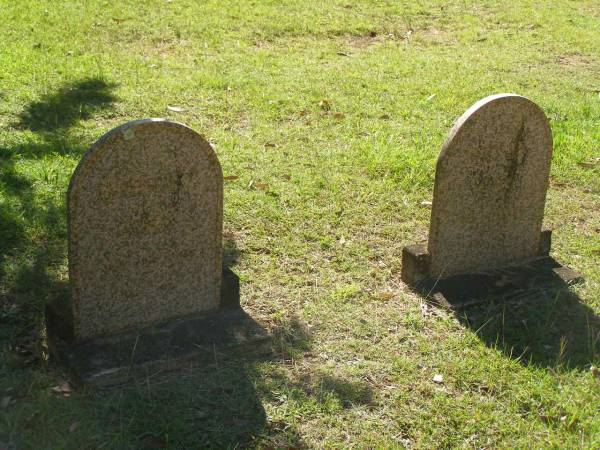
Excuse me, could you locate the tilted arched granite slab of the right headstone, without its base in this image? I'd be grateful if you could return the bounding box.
[428,94,552,277]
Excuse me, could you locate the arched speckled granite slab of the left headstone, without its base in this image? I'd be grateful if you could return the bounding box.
[68,119,223,340]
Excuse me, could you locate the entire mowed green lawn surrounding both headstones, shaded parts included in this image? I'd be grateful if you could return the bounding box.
[0,0,600,449]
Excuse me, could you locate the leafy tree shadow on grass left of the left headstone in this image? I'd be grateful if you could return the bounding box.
[0,78,115,347]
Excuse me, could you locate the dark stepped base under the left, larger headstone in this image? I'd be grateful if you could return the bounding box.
[48,273,271,388]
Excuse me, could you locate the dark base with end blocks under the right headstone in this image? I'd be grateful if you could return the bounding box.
[402,230,583,310]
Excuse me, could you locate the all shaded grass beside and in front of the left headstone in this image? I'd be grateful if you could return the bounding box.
[0,79,322,448]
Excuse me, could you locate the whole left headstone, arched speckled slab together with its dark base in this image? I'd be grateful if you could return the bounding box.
[47,119,269,386]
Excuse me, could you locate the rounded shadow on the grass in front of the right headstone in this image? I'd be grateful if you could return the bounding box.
[455,282,600,370]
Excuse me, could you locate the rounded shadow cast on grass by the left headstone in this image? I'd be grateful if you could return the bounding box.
[93,342,267,448]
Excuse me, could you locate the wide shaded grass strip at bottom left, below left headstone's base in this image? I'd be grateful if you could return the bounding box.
[0,319,314,449]
